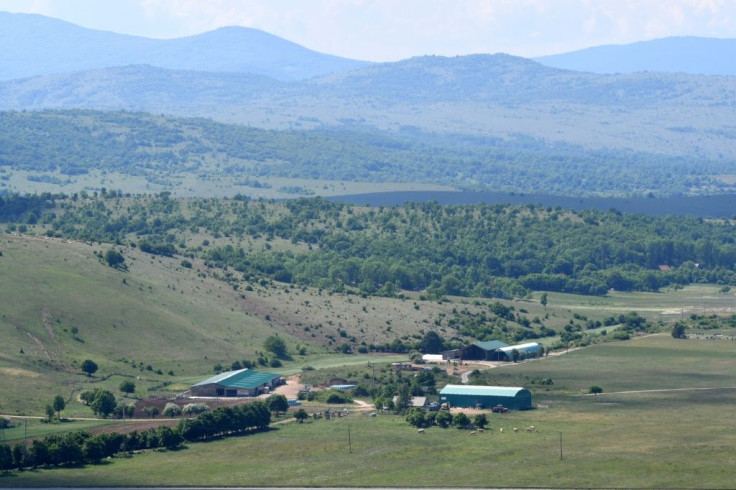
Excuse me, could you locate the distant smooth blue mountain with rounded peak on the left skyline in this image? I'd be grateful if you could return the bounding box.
[0,12,369,81]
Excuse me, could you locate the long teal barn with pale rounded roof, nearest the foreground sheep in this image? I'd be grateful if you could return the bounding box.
[440,385,532,410]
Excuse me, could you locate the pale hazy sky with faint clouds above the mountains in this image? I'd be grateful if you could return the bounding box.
[0,0,736,61]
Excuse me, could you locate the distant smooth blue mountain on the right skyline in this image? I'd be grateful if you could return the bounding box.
[535,37,736,76]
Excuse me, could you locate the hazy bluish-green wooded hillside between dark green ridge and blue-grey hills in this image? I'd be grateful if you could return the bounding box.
[0,111,736,196]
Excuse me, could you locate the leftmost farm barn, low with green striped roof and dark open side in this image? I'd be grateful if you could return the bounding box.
[190,369,284,397]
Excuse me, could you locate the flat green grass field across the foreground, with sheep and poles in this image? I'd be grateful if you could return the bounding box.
[0,335,736,488]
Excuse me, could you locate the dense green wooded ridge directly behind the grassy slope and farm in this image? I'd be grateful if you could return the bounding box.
[0,191,736,298]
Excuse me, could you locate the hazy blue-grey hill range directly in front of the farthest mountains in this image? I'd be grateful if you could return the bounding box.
[0,55,736,165]
